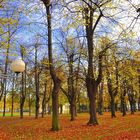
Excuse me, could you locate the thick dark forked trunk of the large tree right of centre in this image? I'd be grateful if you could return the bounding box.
[84,5,103,125]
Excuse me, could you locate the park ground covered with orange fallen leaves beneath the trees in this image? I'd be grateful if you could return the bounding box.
[0,112,140,140]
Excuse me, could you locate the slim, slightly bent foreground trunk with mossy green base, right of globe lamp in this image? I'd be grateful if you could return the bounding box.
[42,0,61,131]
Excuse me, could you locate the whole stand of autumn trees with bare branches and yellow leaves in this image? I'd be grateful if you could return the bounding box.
[0,0,140,131]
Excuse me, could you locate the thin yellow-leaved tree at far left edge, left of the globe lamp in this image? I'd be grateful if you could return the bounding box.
[0,1,19,116]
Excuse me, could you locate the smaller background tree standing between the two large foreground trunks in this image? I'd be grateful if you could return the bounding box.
[60,34,83,121]
